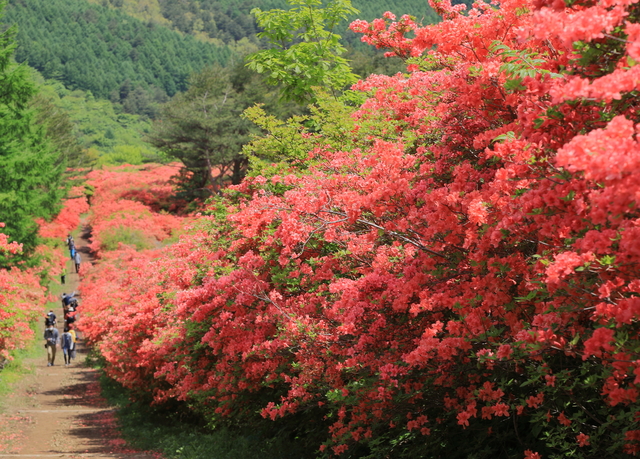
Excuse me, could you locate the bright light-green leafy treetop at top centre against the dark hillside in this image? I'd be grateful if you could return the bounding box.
[247,0,358,103]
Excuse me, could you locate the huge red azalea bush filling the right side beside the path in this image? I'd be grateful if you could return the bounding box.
[82,0,640,457]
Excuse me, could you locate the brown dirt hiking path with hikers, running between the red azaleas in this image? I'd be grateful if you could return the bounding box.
[0,226,159,459]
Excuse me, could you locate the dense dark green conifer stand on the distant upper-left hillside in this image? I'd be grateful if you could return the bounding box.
[4,0,230,98]
